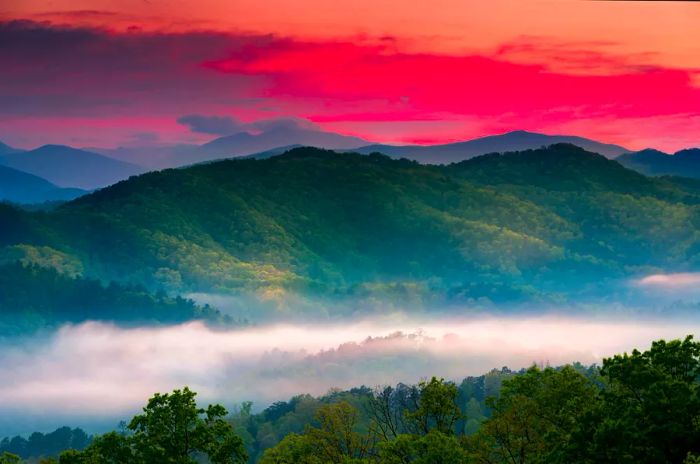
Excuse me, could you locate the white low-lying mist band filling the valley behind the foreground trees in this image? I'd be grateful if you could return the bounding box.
[0,314,700,435]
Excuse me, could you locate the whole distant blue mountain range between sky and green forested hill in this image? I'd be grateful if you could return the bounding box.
[0,129,700,202]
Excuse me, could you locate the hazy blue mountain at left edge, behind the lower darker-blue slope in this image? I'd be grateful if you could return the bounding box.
[0,145,143,190]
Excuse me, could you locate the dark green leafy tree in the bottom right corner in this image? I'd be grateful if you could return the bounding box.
[570,336,700,464]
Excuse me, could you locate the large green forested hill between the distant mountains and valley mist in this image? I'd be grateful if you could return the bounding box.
[0,145,700,302]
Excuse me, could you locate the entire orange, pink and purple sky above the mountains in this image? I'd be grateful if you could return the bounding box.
[0,0,700,152]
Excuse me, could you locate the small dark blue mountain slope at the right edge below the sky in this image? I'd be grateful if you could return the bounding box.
[617,148,700,178]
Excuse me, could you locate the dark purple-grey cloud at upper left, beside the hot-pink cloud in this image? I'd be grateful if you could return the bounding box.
[0,20,275,117]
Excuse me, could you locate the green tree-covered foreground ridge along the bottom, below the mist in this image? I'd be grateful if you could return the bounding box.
[13,336,700,464]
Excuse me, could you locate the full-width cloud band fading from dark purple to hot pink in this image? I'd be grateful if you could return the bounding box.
[0,21,700,150]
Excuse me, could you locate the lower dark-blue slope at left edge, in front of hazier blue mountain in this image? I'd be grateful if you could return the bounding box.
[0,166,85,203]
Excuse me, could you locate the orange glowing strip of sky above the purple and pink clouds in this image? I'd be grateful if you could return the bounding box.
[6,0,700,68]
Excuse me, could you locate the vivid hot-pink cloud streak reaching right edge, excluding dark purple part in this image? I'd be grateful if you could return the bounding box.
[205,41,700,120]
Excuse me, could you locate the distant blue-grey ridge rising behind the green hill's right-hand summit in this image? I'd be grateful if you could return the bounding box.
[353,131,629,164]
